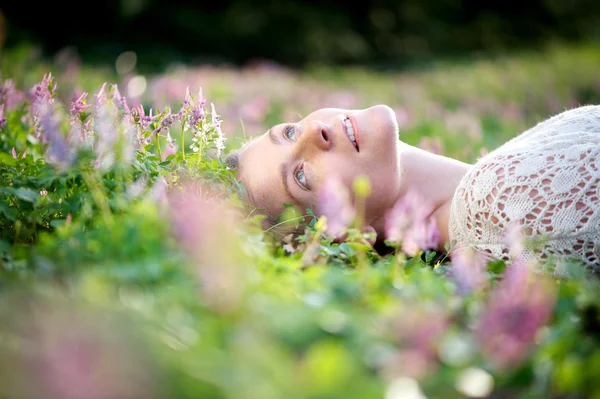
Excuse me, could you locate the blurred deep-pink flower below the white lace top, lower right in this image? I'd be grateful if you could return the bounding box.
[475,258,555,368]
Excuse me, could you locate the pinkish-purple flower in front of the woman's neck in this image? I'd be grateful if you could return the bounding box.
[385,190,440,256]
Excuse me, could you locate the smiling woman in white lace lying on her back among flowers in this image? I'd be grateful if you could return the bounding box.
[227,105,600,269]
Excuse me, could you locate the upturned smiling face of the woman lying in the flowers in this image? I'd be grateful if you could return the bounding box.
[238,105,400,224]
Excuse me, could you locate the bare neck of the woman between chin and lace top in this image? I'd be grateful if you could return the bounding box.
[373,143,471,250]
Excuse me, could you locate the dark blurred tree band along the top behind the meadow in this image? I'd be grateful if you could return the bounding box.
[0,0,600,68]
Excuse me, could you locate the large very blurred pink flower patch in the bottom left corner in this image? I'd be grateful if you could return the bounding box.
[0,290,164,399]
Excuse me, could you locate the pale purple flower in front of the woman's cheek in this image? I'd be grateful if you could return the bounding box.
[318,175,356,236]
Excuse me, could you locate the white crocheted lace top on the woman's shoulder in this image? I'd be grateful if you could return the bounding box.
[449,105,600,273]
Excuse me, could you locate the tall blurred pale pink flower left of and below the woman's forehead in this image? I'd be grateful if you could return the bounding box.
[168,183,244,312]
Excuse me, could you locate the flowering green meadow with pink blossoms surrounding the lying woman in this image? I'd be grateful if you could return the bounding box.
[0,43,600,399]
